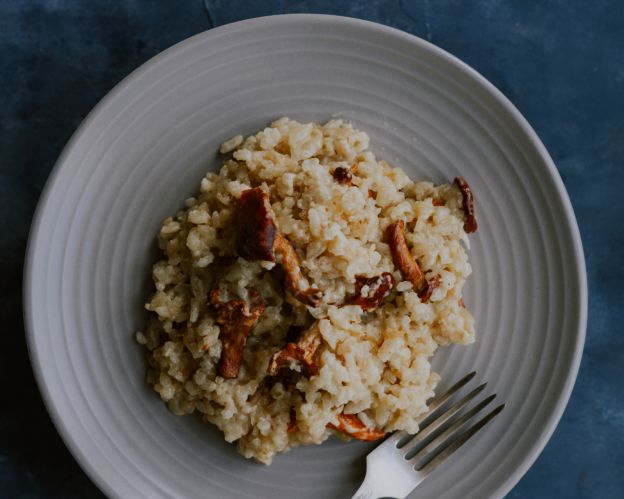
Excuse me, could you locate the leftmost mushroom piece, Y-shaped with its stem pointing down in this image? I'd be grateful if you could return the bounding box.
[210,289,265,379]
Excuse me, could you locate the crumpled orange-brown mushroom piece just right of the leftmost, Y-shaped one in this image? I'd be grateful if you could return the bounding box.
[267,322,322,377]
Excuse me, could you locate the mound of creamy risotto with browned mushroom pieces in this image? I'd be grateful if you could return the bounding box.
[137,118,477,464]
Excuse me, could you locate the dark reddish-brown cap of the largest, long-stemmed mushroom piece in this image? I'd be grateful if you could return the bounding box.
[238,187,277,262]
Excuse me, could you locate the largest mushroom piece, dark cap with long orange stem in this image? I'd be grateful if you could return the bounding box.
[238,187,323,307]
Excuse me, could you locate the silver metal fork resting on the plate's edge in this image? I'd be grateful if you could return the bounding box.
[352,372,505,499]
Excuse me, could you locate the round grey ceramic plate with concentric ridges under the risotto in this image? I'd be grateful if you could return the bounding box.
[25,15,587,498]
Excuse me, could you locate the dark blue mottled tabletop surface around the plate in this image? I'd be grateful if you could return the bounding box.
[0,0,624,498]
